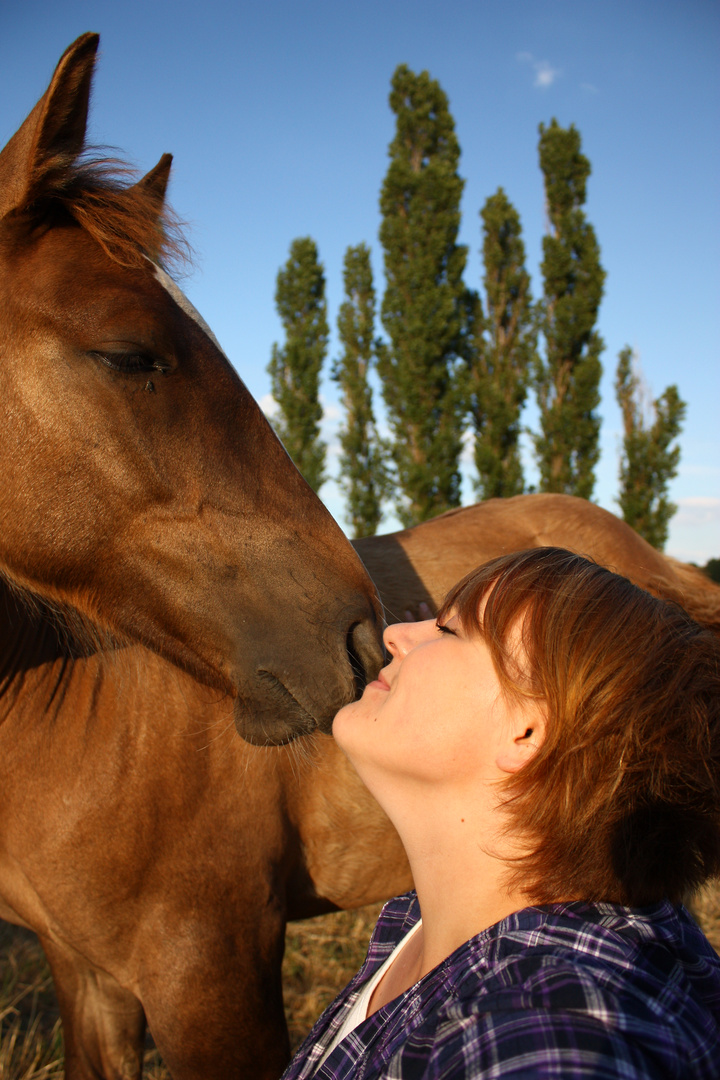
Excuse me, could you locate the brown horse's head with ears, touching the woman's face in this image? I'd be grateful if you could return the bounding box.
[0,33,381,743]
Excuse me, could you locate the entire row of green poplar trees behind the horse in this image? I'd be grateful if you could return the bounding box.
[268,65,685,549]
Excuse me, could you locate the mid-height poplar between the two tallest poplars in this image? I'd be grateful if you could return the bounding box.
[470,188,536,499]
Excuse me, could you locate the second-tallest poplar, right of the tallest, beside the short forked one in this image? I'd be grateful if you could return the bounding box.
[534,120,604,499]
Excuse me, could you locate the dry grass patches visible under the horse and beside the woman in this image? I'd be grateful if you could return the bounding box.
[0,882,720,1080]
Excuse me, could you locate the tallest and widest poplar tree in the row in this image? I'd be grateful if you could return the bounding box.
[378,65,475,525]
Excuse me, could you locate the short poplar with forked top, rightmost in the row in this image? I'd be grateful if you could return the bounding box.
[615,348,685,551]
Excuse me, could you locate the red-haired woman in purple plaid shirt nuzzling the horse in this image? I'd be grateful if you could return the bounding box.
[285,548,720,1080]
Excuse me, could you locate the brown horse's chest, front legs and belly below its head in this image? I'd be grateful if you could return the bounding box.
[0,574,409,1080]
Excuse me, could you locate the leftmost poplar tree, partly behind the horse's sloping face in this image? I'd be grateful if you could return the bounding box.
[268,237,328,491]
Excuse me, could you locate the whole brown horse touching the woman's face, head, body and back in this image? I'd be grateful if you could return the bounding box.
[0,29,720,1080]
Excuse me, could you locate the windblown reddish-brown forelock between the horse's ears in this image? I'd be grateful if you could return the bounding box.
[32,157,192,270]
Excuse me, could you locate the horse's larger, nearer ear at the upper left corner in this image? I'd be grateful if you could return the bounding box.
[0,33,100,217]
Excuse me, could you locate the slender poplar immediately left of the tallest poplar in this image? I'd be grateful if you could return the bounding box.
[332,244,389,537]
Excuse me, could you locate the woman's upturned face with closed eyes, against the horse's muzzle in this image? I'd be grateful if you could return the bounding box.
[332,617,536,801]
